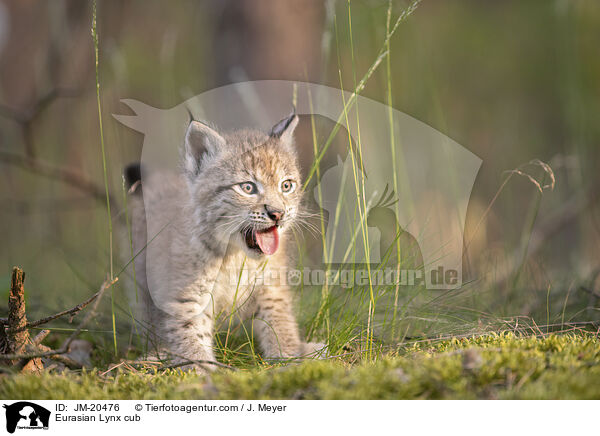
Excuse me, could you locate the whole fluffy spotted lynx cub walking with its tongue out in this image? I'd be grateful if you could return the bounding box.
[127,115,325,368]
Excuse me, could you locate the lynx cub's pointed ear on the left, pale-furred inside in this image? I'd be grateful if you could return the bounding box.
[184,121,225,176]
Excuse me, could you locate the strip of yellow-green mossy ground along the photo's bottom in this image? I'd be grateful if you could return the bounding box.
[0,333,600,399]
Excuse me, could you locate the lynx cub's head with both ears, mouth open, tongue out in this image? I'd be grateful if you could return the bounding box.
[184,115,302,259]
